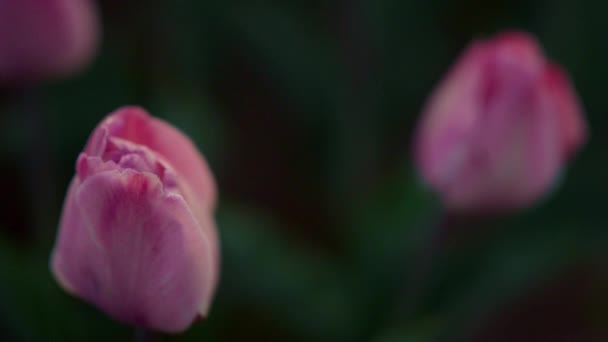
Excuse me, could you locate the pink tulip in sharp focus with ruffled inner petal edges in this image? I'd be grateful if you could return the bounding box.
[52,107,219,332]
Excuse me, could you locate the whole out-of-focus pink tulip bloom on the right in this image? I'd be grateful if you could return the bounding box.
[415,32,587,212]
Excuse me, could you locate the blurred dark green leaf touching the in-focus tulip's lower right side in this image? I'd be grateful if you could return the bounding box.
[210,207,354,341]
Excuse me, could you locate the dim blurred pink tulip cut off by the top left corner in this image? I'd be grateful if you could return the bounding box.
[0,0,99,84]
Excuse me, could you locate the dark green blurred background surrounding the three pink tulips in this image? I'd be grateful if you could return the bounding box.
[0,0,608,342]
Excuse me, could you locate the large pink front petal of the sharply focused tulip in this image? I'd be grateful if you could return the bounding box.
[53,169,215,332]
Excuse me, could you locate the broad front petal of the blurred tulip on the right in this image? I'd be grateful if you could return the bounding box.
[442,69,560,211]
